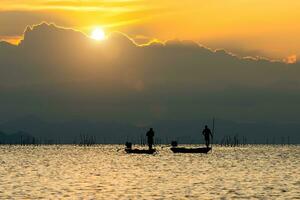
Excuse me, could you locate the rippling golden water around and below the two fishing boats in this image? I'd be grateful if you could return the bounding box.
[0,145,300,199]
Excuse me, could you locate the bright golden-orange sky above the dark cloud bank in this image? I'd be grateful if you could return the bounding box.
[0,0,300,62]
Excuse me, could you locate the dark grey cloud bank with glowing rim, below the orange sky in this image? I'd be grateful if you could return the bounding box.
[0,24,300,143]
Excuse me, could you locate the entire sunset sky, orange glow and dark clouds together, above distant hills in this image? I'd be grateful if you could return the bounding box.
[0,4,300,141]
